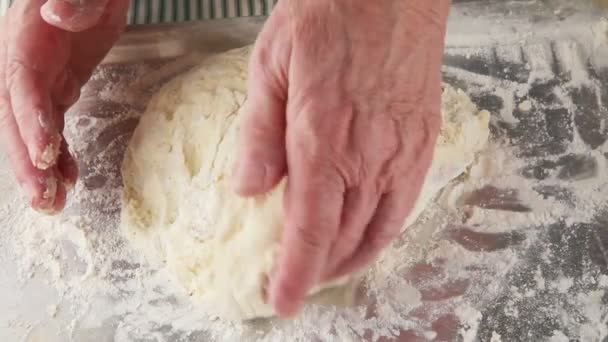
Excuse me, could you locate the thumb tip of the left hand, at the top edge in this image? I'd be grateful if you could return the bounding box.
[40,0,110,32]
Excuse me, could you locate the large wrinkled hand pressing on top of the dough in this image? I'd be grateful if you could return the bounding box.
[235,0,449,316]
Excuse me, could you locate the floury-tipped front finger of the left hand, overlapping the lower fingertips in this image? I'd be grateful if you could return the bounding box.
[5,0,63,170]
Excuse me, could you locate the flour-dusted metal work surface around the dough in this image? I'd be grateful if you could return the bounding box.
[0,5,608,341]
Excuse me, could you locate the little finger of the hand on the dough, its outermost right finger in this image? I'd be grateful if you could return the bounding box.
[332,191,413,278]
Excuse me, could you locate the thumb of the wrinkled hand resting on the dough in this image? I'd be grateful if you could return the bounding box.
[234,41,286,196]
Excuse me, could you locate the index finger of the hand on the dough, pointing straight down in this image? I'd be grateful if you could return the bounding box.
[270,163,344,317]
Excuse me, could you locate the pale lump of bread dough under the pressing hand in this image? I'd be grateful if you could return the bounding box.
[122,48,489,320]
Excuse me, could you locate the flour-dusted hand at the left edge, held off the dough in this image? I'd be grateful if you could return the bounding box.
[0,0,128,213]
